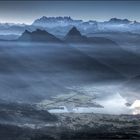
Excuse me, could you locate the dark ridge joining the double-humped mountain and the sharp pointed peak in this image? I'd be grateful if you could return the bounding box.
[18,27,118,44]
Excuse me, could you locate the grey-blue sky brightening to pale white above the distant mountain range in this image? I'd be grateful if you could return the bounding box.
[0,1,140,24]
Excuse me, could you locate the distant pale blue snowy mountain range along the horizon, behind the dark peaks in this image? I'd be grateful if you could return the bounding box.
[0,16,140,36]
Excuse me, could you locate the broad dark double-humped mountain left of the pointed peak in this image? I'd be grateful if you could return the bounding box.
[18,29,61,43]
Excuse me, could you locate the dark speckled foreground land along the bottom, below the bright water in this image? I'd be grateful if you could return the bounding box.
[0,113,140,140]
